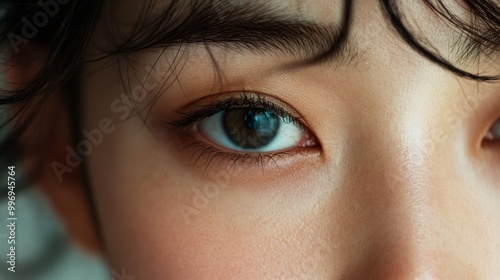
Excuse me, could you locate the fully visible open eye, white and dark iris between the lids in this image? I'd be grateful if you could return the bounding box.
[198,107,315,153]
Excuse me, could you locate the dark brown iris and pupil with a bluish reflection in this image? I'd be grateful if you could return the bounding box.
[223,108,280,149]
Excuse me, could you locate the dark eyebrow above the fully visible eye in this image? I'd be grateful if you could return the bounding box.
[108,0,352,62]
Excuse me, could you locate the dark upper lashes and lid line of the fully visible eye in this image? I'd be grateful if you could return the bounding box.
[164,92,304,128]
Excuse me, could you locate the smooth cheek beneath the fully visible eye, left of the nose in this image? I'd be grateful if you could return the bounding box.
[84,121,338,279]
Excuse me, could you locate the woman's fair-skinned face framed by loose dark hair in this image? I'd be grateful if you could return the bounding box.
[75,0,500,279]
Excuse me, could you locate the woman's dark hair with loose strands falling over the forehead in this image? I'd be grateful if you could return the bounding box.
[0,0,500,179]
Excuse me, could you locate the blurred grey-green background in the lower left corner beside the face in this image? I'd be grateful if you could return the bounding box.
[0,77,110,280]
